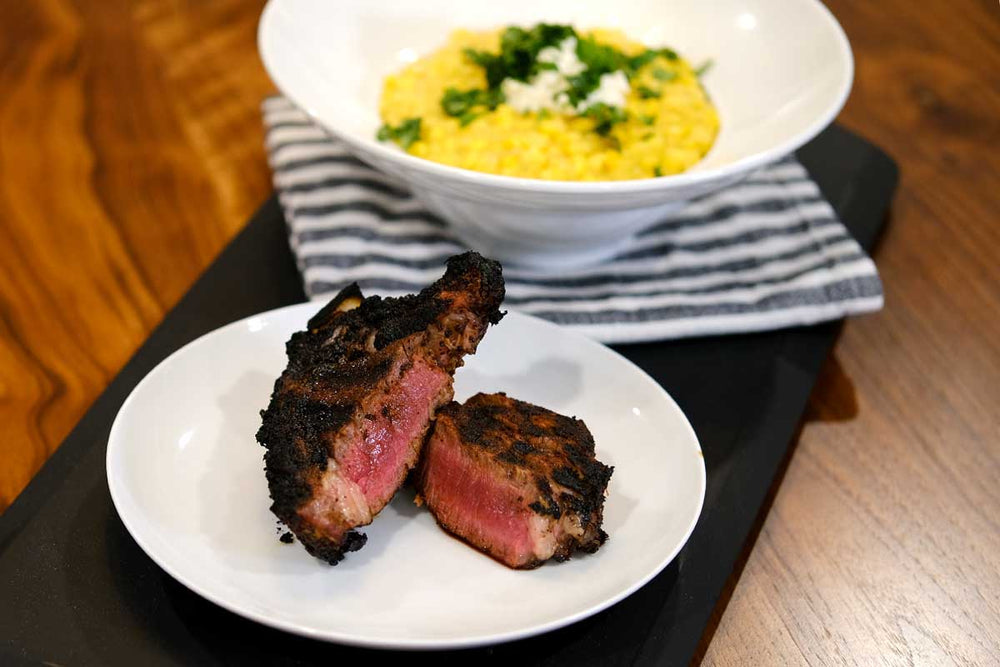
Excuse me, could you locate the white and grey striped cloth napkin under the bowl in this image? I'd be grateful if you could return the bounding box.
[263,97,882,343]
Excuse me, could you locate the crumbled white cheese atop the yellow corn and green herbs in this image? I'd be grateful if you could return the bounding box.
[501,37,630,114]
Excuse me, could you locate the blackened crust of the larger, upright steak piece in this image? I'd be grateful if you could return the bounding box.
[257,252,504,564]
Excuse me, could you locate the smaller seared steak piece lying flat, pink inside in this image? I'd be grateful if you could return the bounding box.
[416,394,613,569]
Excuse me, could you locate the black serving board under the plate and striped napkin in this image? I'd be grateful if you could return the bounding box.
[0,126,897,665]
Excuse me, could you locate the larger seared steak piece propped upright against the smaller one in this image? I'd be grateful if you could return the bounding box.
[257,252,504,564]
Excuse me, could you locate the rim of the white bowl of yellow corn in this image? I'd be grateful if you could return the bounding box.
[257,0,854,195]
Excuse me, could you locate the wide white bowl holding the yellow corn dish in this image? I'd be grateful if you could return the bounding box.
[258,0,854,271]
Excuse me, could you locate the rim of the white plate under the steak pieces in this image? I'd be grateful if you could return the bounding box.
[105,301,707,651]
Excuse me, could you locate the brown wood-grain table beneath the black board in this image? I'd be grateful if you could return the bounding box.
[0,0,1000,665]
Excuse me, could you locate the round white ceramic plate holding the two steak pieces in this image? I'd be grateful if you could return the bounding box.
[107,304,705,648]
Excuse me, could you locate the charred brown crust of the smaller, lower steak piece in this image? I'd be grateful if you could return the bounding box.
[417,393,614,568]
